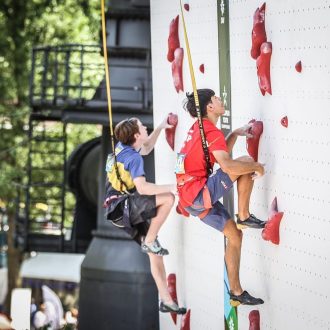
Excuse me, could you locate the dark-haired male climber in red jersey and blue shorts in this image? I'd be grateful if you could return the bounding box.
[176,89,265,305]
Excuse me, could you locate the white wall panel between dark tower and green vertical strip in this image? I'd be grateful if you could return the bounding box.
[151,0,224,330]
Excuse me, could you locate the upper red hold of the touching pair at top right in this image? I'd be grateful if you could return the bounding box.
[251,3,267,60]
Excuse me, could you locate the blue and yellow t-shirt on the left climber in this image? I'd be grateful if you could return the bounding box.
[106,142,145,191]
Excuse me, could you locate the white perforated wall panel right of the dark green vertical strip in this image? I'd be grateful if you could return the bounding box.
[230,1,330,330]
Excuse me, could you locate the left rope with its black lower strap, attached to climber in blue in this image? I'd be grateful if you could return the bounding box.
[101,0,128,193]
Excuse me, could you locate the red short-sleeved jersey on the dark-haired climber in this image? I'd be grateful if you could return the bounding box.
[176,119,228,207]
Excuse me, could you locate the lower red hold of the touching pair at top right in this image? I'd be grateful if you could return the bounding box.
[257,42,272,95]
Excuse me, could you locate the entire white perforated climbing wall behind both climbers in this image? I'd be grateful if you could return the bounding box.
[151,0,330,330]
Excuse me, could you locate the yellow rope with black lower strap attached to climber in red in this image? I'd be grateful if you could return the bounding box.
[180,0,212,175]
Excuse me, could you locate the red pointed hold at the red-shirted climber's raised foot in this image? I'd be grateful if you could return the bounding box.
[261,197,284,245]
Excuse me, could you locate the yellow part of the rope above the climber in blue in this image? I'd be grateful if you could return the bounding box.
[101,0,115,152]
